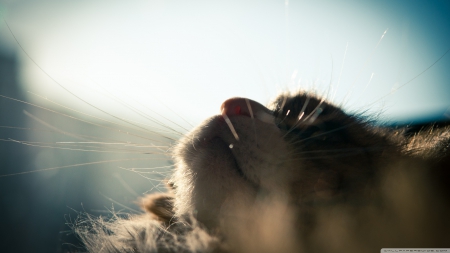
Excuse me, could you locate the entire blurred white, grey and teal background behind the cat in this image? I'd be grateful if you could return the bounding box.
[0,0,450,252]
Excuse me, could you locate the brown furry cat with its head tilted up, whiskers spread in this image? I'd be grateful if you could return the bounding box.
[73,91,450,252]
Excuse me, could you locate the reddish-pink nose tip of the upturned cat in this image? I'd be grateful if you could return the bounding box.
[220,98,273,123]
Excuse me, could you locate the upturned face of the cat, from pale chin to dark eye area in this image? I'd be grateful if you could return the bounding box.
[171,93,399,227]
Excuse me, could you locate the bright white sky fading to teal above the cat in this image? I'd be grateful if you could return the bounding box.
[0,0,450,128]
